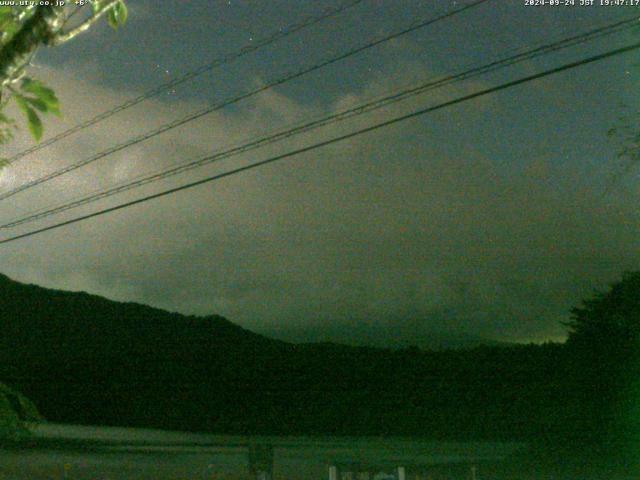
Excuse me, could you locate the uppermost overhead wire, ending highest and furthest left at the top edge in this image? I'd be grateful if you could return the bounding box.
[0,0,364,164]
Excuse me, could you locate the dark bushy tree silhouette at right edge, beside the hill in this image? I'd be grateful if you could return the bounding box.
[567,271,640,442]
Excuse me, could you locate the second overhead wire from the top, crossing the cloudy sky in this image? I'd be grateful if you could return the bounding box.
[0,0,489,201]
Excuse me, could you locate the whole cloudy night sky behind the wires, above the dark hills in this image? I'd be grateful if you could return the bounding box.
[0,0,640,345]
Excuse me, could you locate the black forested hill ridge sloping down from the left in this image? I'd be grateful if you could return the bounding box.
[0,270,639,446]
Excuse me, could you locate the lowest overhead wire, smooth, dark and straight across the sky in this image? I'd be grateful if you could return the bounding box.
[0,42,640,248]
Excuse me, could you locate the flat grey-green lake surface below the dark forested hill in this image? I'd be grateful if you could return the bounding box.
[0,424,521,480]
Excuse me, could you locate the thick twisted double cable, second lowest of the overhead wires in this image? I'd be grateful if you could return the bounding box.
[0,17,638,229]
